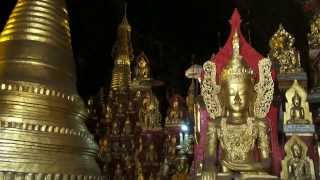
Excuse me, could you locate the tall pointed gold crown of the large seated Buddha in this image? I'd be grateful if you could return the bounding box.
[220,32,253,82]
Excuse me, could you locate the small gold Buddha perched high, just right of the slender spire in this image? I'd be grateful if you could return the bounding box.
[133,52,150,81]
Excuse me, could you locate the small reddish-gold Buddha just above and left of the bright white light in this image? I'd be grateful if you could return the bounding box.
[165,95,184,126]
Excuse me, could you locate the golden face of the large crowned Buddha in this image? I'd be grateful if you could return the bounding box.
[224,81,251,113]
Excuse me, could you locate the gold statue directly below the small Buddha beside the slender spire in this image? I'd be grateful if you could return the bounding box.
[139,92,161,129]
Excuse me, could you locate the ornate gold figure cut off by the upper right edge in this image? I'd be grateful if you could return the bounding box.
[308,13,320,49]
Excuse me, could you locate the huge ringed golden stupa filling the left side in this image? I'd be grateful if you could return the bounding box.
[0,0,100,180]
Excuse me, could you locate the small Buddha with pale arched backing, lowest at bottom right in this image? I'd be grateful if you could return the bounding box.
[281,135,316,180]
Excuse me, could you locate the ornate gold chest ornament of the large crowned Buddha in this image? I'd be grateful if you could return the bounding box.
[218,120,258,161]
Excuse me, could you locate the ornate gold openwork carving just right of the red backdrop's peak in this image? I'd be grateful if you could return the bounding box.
[269,24,303,74]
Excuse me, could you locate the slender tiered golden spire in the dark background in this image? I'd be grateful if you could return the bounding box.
[111,4,133,91]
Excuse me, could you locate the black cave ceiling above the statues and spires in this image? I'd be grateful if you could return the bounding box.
[0,0,308,96]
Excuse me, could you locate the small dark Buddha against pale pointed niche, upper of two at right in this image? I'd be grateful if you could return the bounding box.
[283,80,312,124]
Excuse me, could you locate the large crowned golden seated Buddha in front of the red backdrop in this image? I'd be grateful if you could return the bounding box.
[201,33,273,180]
